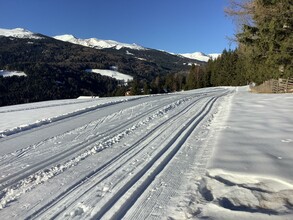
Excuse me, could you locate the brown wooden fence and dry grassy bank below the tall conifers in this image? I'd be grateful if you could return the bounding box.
[250,78,293,93]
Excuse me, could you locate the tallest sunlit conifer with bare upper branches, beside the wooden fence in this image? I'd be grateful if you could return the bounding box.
[227,0,293,82]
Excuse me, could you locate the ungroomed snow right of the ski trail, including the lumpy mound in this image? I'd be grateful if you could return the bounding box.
[173,87,293,219]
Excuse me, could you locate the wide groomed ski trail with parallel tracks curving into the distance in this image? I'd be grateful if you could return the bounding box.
[0,88,233,219]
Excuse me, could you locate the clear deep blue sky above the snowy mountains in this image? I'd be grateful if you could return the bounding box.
[0,0,234,53]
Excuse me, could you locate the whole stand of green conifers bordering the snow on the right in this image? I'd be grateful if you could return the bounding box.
[206,0,293,86]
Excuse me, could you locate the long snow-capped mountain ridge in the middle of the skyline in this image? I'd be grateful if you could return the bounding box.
[54,34,146,50]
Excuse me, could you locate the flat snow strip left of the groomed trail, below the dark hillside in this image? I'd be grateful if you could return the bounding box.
[0,97,134,138]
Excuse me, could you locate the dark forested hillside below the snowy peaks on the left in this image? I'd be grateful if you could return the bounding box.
[0,35,200,106]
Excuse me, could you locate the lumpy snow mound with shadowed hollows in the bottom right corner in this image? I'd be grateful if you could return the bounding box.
[177,169,293,219]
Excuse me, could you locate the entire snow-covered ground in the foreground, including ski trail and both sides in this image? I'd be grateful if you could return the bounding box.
[0,87,293,219]
